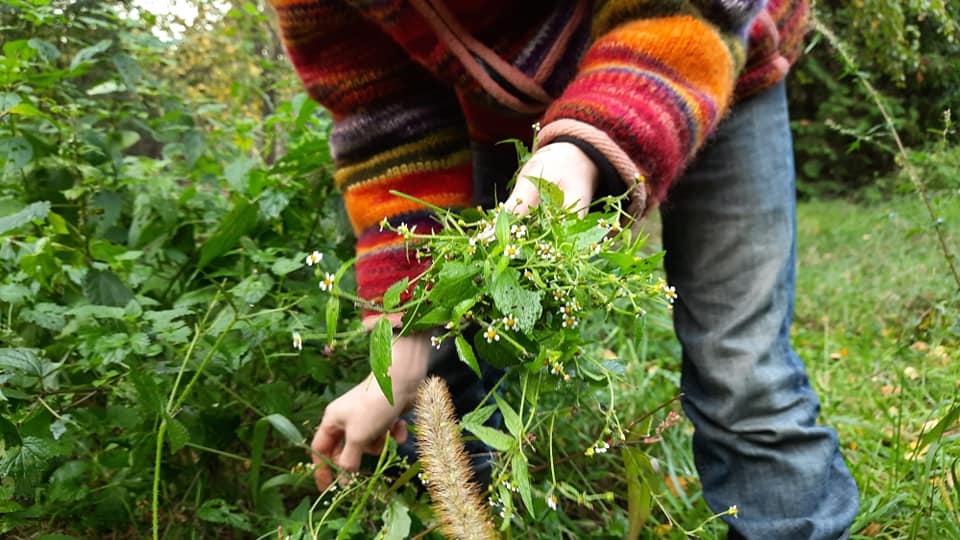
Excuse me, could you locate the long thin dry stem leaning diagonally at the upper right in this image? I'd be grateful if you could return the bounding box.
[811,16,960,290]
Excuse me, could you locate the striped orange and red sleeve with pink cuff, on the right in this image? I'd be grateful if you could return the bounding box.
[538,0,765,213]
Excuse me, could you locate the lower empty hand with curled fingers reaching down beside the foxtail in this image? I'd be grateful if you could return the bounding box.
[310,334,430,491]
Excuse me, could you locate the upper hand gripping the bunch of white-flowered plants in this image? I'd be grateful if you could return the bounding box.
[506,142,599,217]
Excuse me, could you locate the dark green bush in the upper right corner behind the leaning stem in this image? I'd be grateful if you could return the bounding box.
[789,0,960,195]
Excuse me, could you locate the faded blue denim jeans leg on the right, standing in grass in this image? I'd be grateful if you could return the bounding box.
[661,83,859,539]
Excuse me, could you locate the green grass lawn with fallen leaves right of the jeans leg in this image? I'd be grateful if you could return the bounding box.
[637,193,960,539]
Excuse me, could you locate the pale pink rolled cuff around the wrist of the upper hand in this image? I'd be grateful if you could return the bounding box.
[534,118,649,216]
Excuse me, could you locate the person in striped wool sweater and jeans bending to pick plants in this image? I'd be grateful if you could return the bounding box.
[271,0,858,539]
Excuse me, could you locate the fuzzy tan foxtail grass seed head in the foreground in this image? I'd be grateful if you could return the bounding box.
[416,377,498,540]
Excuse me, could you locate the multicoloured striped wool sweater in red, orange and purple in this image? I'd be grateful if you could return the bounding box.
[271,0,808,316]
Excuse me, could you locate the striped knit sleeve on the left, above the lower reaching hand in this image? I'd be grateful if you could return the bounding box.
[271,0,473,320]
